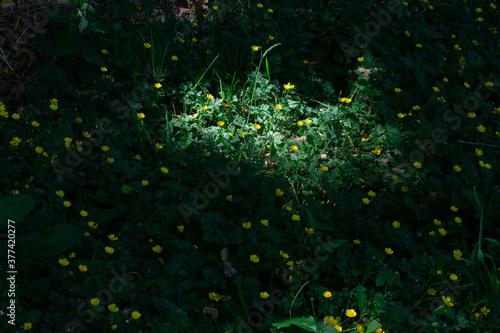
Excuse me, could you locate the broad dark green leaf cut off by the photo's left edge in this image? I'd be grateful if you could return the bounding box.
[0,194,36,229]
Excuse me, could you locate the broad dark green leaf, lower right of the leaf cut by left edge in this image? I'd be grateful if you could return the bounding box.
[40,224,85,257]
